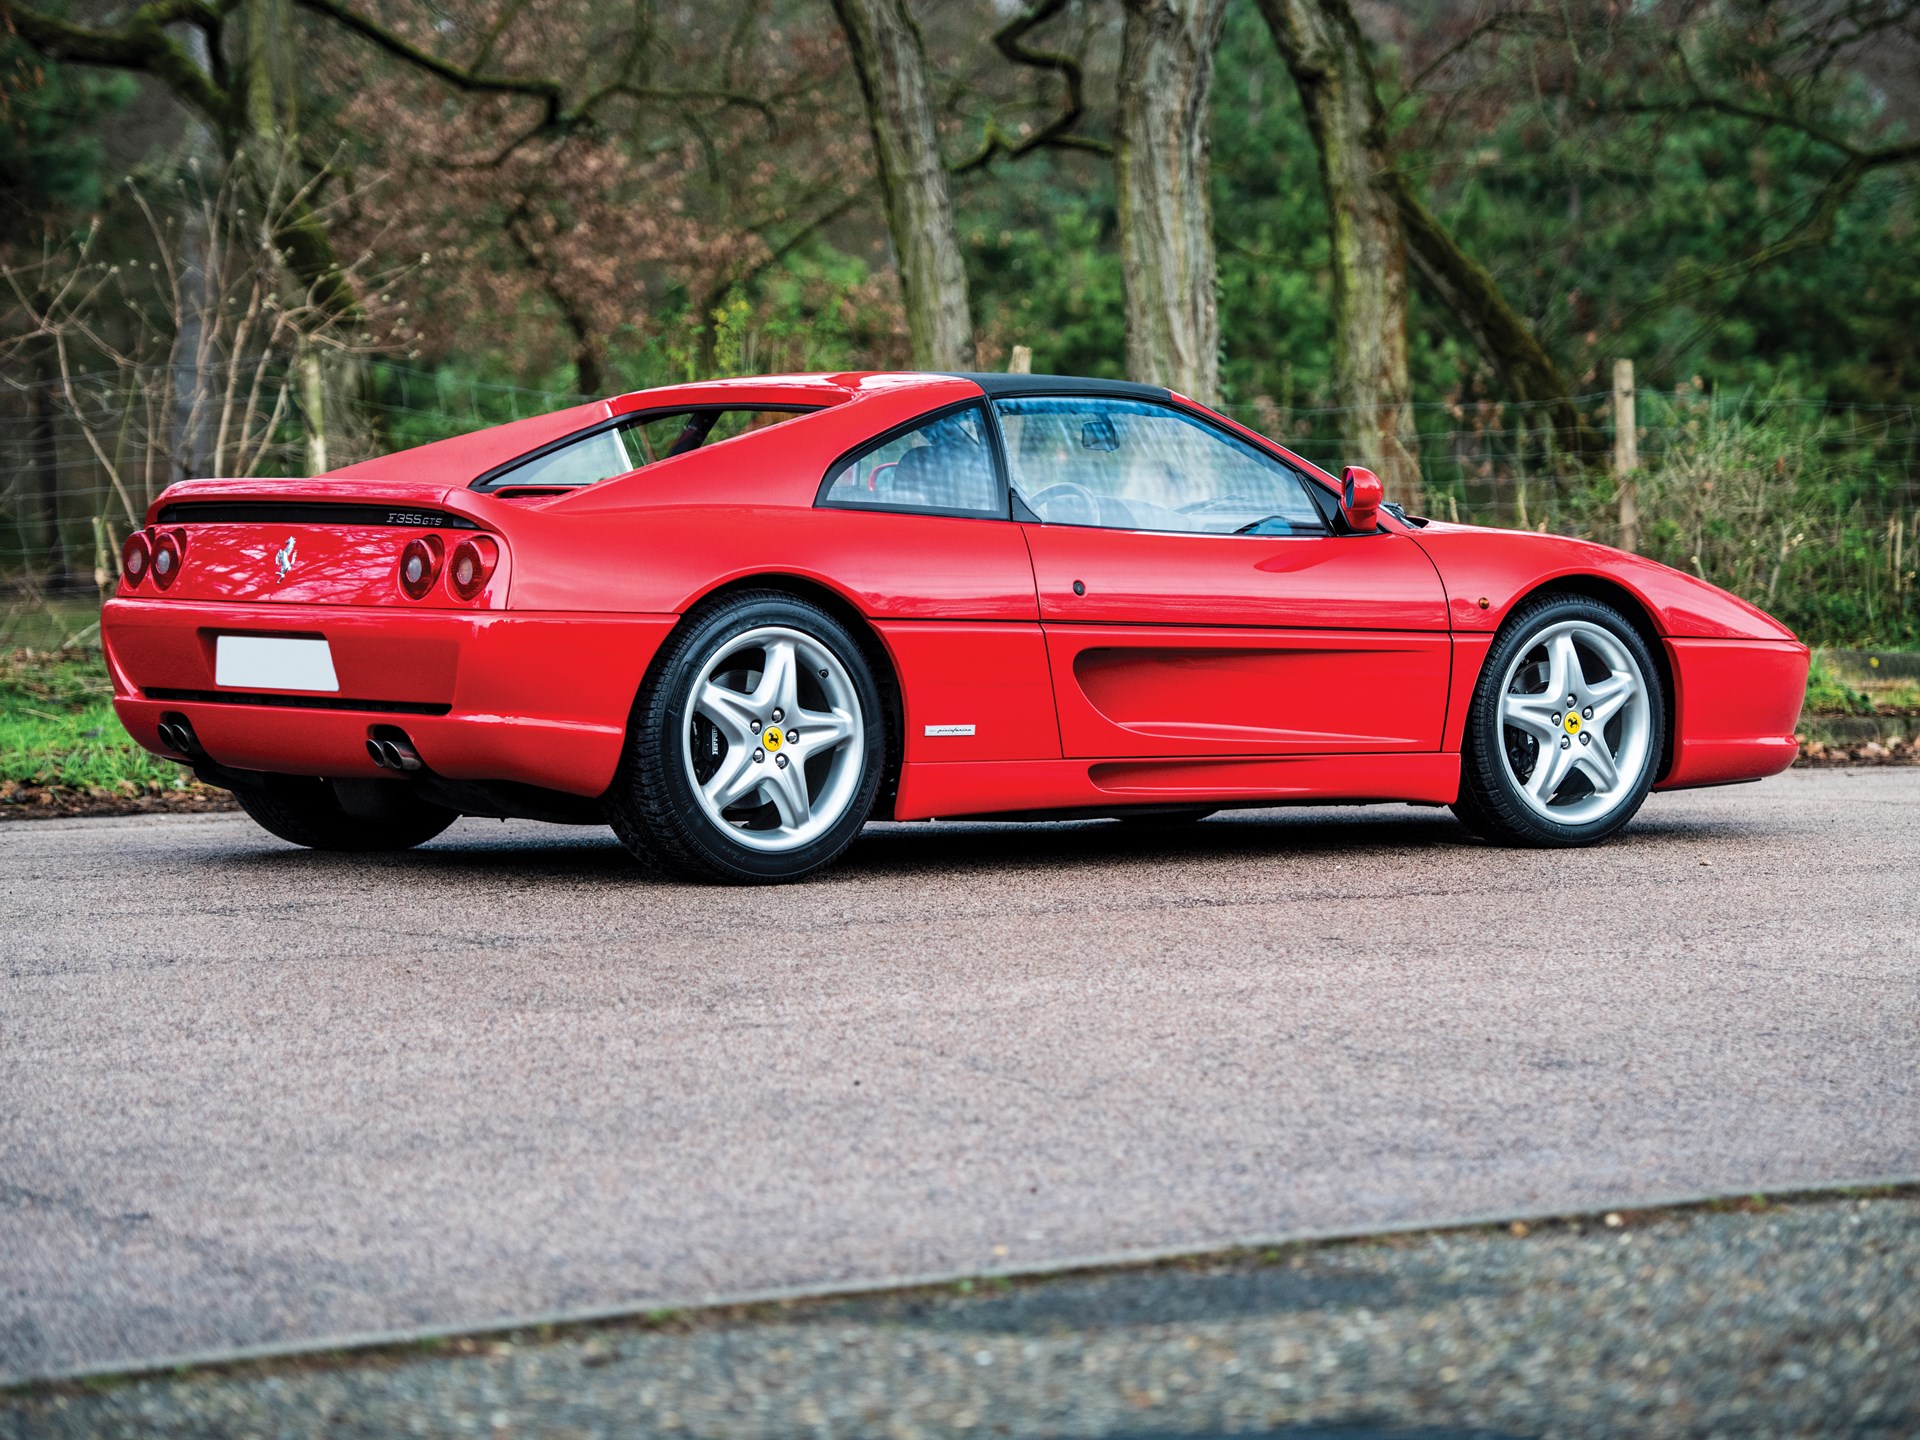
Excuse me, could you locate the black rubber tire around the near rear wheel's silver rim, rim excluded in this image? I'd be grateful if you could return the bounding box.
[605,589,887,885]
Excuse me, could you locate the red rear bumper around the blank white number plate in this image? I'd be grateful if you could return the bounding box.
[100,599,678,795]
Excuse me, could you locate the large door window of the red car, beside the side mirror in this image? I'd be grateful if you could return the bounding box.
[995,397,1327,536]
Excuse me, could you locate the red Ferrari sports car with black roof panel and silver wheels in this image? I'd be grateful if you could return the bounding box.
[102,374,1807,883]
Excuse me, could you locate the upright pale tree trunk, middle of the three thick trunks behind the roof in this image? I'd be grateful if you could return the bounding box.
[1116,0,1227,405]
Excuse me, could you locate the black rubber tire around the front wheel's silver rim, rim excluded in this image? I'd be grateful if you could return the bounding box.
[1453,595,1667,847]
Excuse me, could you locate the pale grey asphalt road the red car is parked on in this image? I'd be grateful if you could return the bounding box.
[0,768,1920,1377]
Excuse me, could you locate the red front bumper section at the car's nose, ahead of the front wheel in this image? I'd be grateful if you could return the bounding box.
[1655,639,1809,789]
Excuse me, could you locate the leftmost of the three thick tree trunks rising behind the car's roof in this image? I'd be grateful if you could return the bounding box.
[833,0,973,371]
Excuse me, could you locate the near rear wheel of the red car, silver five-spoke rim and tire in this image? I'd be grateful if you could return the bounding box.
[607,591,887,885]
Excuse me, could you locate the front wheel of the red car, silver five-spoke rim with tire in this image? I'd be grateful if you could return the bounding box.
[1453,595,1667,845]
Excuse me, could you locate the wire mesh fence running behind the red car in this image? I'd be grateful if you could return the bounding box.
[0,361,1920,643]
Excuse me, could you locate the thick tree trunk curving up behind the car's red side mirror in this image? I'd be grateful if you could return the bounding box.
[1260,0,1421,509]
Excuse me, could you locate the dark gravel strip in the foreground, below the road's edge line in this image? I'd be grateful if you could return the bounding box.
[0,1198,1920,1440]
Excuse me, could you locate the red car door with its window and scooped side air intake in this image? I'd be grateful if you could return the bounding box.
[995,396,1452,758]
